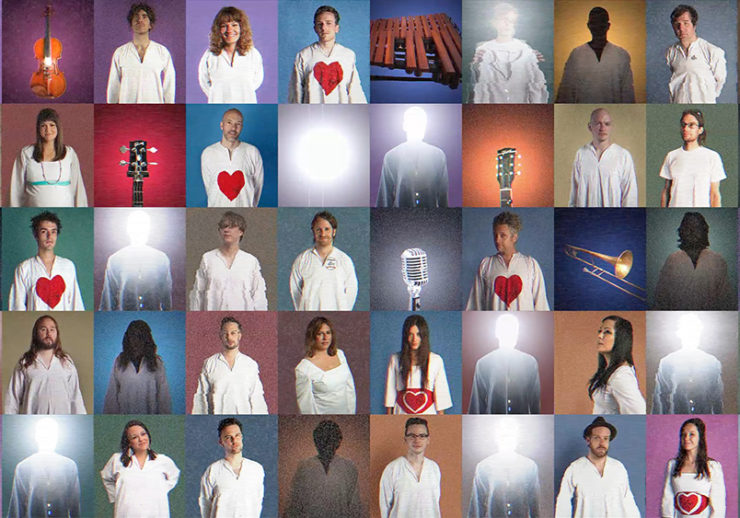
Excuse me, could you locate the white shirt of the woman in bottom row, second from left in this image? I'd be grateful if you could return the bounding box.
[100,453,180,518]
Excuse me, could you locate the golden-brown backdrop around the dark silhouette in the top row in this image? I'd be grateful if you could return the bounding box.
[554,0,644,103]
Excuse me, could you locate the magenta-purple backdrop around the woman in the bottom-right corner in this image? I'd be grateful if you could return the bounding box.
[644,415,737,516]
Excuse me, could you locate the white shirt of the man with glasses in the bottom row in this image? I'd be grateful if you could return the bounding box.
[380,457,442,518]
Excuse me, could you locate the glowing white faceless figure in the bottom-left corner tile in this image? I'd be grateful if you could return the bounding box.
[8,417,80,518]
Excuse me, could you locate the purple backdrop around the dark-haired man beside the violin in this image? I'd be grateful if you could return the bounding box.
[94,0,185,103]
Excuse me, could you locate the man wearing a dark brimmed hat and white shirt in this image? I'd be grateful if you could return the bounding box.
[555,416,640,518]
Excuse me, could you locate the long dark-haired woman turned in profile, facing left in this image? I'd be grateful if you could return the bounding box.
[588,315,645,414]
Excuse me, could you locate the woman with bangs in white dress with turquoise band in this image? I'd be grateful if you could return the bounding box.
[10,108,87,207]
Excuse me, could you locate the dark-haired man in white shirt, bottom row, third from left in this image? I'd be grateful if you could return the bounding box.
[198,417,265,518]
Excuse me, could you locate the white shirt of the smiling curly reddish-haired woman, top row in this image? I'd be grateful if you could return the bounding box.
[198,47,264,103]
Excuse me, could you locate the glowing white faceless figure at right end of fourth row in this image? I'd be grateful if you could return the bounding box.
[652,313,724,414]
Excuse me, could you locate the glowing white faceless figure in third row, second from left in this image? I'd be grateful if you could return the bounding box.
[98,210,172,311]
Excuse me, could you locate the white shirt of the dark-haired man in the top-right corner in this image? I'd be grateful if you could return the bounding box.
[665,38,727,104]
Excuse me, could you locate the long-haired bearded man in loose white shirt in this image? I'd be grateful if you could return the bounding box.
[5,315,87,414]
